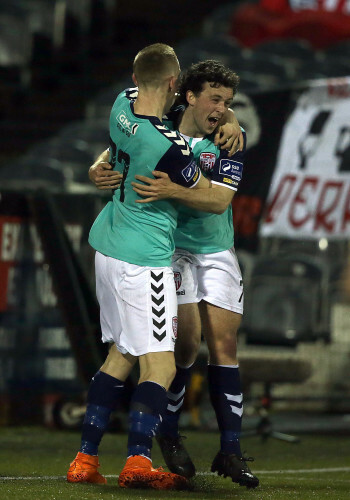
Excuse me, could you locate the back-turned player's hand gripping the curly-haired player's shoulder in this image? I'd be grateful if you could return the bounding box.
[214,108,244,157]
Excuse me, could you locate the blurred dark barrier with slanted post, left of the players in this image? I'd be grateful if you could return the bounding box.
[0,191,103,423]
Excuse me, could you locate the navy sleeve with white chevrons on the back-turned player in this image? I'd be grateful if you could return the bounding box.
[155,134,201,188]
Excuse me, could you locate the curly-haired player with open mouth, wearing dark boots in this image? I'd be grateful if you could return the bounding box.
[90,61,259,487]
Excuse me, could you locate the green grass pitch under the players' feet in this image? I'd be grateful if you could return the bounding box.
[0,427,350,500]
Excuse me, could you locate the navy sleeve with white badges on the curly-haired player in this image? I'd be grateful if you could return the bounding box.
[211,132,247,191]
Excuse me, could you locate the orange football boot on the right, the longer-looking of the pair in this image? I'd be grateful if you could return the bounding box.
[118,455,189,490]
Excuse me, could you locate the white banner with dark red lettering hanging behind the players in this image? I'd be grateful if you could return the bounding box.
[260,77,350,239]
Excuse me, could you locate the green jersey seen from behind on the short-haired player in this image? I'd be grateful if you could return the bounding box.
[89,89,201,267]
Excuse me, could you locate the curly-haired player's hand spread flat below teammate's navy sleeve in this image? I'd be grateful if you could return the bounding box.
[131,170,177,203]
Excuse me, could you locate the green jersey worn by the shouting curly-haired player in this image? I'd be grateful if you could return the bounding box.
[163,109,246,254]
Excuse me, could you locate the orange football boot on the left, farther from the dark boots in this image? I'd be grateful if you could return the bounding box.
[67,451,107,484]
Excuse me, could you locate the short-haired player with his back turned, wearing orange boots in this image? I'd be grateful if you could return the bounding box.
[67,44,215,489]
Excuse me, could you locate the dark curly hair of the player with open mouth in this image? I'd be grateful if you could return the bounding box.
[176,59,239,106]
